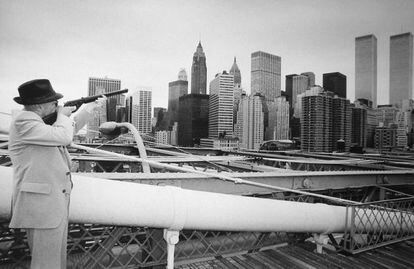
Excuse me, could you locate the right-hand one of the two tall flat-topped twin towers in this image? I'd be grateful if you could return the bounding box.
[390,33,414,106]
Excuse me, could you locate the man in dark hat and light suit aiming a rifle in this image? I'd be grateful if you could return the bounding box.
[9,79,102,269]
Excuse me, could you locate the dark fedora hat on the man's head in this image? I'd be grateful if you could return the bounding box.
[14,79,63,105]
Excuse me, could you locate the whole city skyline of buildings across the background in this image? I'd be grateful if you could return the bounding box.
[78,33,414,152]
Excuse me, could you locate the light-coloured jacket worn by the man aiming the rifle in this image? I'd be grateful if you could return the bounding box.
[9,110,90,229]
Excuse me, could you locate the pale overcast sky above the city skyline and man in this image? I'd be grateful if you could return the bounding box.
[0,0,414,127]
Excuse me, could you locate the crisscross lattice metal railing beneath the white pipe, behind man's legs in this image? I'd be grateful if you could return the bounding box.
[0,223,291,269]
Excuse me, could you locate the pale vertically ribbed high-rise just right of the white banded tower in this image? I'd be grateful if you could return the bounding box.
[235,94,264,150]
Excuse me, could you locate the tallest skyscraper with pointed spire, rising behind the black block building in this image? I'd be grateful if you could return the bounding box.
[191,41,207,94]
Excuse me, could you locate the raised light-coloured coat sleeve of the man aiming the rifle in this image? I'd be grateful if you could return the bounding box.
[16,114,73,146]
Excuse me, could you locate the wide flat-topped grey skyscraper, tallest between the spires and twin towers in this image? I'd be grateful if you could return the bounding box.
[251,51,281,100]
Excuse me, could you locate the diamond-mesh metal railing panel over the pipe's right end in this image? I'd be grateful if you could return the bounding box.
[340,197,414,254]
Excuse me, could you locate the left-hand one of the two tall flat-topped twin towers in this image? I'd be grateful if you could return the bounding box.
[355,35,377,107]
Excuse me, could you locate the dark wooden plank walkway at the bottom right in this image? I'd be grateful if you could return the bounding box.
[180,241,414,269]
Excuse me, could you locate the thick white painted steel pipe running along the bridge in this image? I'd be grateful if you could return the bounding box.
[0,166,413,233]
